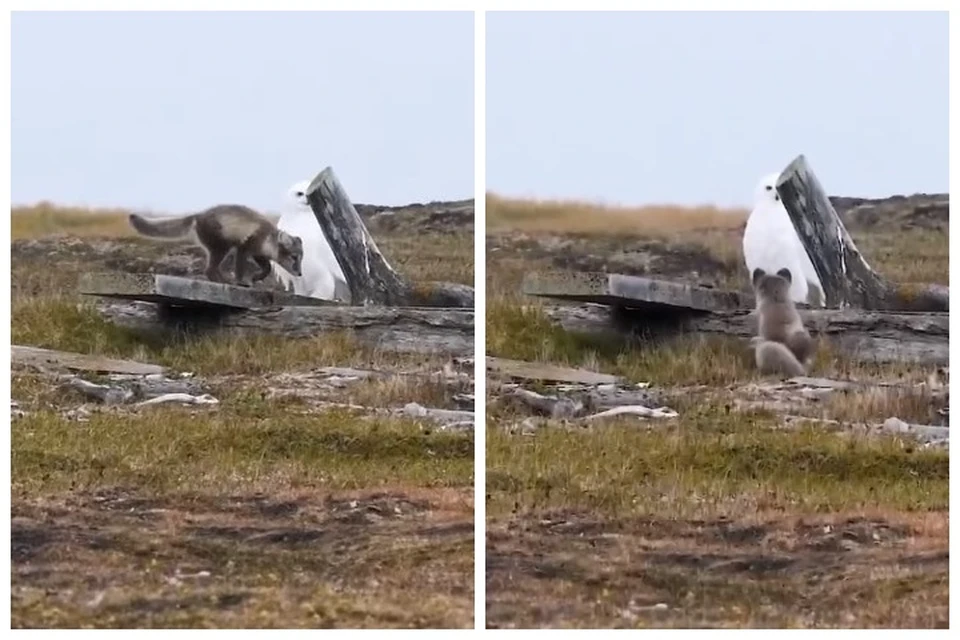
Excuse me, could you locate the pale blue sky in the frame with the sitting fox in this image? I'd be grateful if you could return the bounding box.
[486,11,949,206]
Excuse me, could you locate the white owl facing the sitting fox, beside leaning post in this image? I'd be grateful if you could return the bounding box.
[743,173,824,306]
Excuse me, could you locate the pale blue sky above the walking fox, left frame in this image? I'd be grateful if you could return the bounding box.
[11,12,474,213]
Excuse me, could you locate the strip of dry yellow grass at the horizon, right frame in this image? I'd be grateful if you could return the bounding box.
[487,193,750,237]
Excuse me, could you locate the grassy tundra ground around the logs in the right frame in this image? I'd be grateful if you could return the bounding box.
[486,196,949,628]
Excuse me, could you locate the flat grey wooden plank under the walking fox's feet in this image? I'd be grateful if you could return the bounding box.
[79,273,338,309]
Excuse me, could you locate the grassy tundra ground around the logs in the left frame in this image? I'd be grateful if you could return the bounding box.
[11,205,473,628]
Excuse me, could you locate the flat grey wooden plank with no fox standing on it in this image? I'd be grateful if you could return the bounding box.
[523,272,753,312]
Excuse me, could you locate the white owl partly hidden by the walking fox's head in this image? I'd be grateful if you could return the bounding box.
[273,180,350,301]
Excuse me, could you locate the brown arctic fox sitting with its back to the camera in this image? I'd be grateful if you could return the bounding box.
[750,269,815,377]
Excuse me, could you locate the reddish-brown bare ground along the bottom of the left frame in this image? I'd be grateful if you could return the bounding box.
[11,488,473,628]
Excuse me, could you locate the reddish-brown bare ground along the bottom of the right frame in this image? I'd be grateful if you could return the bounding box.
[487,513,949,628]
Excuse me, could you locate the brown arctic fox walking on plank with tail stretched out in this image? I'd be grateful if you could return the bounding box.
[130,204,303,287]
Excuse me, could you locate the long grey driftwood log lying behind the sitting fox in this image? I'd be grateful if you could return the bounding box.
[543,305,950,366]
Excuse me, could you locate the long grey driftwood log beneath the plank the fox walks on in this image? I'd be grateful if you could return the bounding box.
[97,299,474,356]
